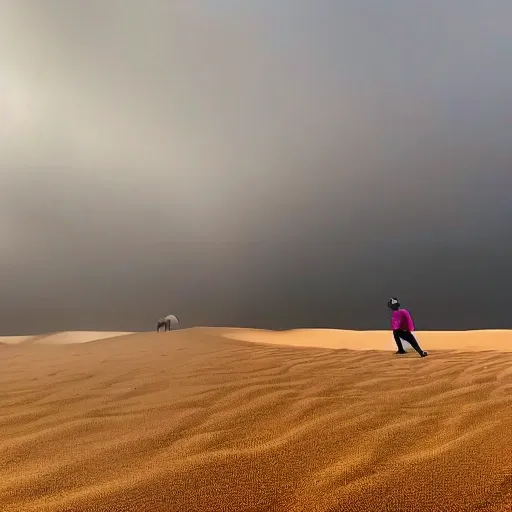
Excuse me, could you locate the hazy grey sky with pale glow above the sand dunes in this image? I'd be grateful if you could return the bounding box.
[0,0,512,334]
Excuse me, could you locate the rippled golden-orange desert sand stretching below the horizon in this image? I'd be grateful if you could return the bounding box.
[0,328,512,512]
